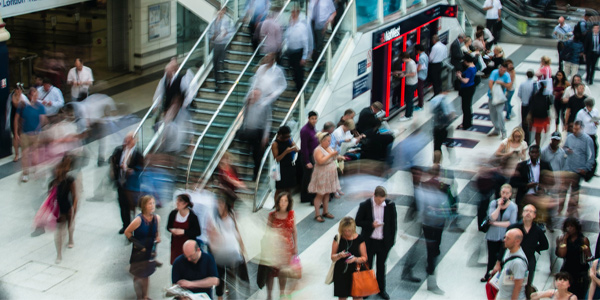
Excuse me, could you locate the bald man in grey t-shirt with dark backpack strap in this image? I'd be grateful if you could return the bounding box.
[496,228,529,300]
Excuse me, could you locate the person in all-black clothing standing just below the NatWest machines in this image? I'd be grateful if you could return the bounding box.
[356,101,394,160]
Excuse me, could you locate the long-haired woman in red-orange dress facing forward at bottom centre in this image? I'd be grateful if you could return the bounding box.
[267,192,298,299]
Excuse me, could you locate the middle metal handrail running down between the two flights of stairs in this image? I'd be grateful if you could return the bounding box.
[185,0,292,189]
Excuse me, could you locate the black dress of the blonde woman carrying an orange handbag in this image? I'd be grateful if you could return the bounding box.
[333,235,365,298]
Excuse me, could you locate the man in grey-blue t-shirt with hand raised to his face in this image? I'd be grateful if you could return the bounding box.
[481,184,518,282]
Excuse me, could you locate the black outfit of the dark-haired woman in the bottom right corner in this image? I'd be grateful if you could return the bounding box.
[560,234,590,299]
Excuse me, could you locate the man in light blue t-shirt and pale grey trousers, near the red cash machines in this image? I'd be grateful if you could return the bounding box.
[488,63,512,139]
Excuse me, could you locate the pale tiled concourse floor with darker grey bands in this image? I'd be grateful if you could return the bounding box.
[0,45,600,299]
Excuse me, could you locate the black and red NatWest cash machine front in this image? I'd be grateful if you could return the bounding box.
[371,5,457,117]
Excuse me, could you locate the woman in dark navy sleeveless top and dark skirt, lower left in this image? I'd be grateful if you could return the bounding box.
[125,196,160,299]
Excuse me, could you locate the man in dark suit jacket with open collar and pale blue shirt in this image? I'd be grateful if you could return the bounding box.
[510,145,553,213]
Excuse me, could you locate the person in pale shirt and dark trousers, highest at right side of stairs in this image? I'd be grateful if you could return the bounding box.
[308,0,336,62]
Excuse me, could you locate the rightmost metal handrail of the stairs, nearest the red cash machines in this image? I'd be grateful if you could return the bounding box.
[253,0,354,211]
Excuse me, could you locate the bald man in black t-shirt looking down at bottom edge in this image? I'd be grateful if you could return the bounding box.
[171,240,219,299]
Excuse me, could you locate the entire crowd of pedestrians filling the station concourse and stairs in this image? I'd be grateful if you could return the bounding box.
[9,0,600,299]
